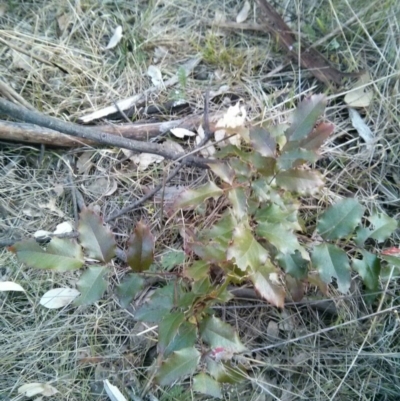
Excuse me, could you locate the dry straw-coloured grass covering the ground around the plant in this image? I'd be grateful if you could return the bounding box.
[0,0,400,401]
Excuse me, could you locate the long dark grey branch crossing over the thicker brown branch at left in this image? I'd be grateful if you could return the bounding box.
[0,99,209,168]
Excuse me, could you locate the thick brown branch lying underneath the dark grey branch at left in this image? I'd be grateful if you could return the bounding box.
[0,113,222,147]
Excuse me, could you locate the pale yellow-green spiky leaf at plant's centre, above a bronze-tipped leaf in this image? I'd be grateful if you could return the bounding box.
[227,224,268,271]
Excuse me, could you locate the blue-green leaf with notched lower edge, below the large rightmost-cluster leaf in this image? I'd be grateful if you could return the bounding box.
[311,244,351,294]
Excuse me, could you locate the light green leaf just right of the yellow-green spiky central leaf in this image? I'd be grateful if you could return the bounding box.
[256,223,304,253]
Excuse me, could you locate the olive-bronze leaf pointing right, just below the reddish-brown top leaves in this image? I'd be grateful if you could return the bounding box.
[276,169,324,195]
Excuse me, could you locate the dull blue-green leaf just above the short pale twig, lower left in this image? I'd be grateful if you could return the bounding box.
[135,284,176,323]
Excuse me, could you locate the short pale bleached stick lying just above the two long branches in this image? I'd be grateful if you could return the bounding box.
[79,57,201,123]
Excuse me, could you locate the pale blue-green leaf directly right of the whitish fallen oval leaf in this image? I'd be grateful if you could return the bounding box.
[74,266,109,305]
